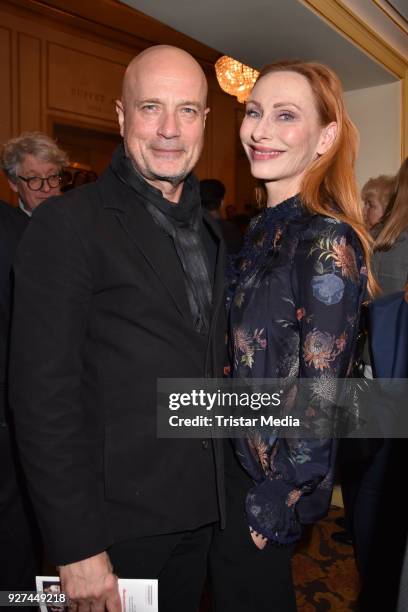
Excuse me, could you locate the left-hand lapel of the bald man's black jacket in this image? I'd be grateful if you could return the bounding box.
[99,168,191,319]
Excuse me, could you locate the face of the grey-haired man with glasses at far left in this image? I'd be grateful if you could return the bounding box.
[8,155,61,211]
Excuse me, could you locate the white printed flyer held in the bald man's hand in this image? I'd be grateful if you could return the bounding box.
[36,576,159,612]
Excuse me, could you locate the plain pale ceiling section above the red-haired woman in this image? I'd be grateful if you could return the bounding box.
[118,0,397,90]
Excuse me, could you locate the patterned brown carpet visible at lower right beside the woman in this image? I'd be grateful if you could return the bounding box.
[293,507,359,612]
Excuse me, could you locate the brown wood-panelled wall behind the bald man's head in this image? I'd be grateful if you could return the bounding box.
[0,0,249,205]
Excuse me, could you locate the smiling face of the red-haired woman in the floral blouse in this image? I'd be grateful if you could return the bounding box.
[240,71,336,204]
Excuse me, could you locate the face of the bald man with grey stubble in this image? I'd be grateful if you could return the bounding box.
[117,56,208,197]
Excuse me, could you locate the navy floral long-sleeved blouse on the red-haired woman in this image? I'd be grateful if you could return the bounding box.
[228,197,367,544]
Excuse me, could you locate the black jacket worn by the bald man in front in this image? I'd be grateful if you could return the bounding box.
[10,163,225,564]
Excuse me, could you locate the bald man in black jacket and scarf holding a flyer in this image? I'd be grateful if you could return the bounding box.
[10,46,224,612]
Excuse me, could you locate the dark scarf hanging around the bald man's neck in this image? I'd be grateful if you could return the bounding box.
[111,145,212,334]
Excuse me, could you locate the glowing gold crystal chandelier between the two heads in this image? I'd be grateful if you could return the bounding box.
[215,55,259,102]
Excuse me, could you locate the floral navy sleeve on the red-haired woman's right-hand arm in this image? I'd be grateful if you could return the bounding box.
[242,218,366,543]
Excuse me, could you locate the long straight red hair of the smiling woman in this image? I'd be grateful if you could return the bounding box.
[253,61,378,295]
